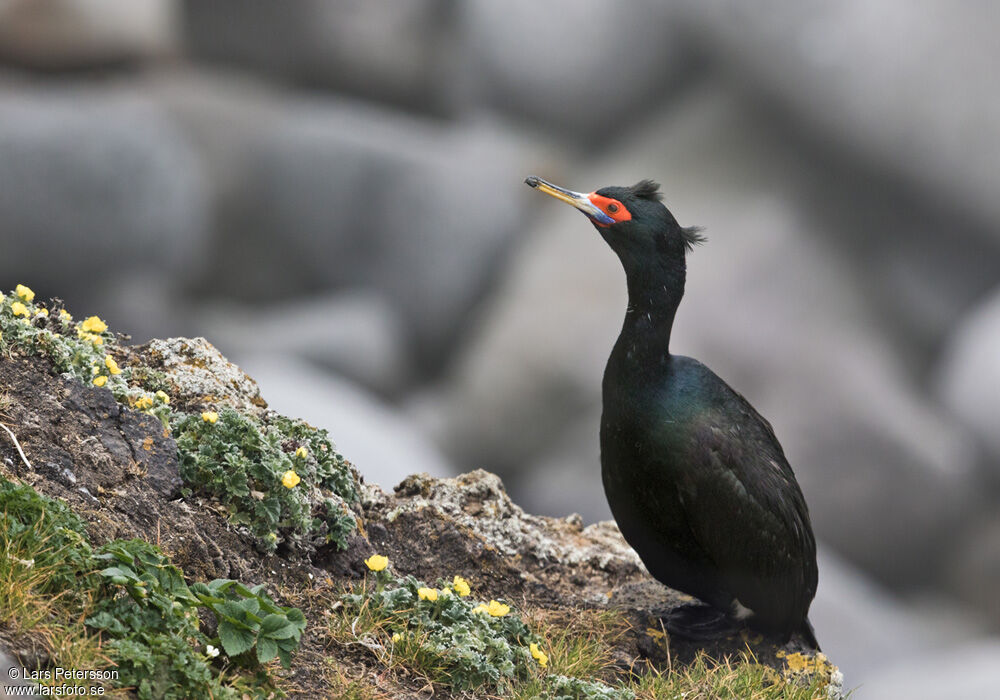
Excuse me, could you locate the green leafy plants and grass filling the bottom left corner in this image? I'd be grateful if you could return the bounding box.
[0,479,305,700]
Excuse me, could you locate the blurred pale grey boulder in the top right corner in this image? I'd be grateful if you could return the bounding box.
[672,0,1000,235]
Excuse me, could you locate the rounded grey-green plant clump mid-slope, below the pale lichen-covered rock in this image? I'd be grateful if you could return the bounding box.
[173,408,358,551]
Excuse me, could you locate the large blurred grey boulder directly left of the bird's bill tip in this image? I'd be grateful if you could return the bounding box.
[150,70,545,368]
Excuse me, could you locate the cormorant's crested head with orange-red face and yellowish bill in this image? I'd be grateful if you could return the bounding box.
[524,176,704,272]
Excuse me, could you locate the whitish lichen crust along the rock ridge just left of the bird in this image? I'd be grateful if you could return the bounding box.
[364,469,642,571]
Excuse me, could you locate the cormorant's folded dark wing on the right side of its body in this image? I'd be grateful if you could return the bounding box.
[680,400,817,624]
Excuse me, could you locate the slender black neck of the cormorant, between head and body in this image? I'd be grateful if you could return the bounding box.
[615,268,684,368]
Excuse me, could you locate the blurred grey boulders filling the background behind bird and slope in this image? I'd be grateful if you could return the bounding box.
[0,0,1000,700]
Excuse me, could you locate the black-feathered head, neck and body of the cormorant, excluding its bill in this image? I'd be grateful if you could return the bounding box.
[528,175,817,646]
